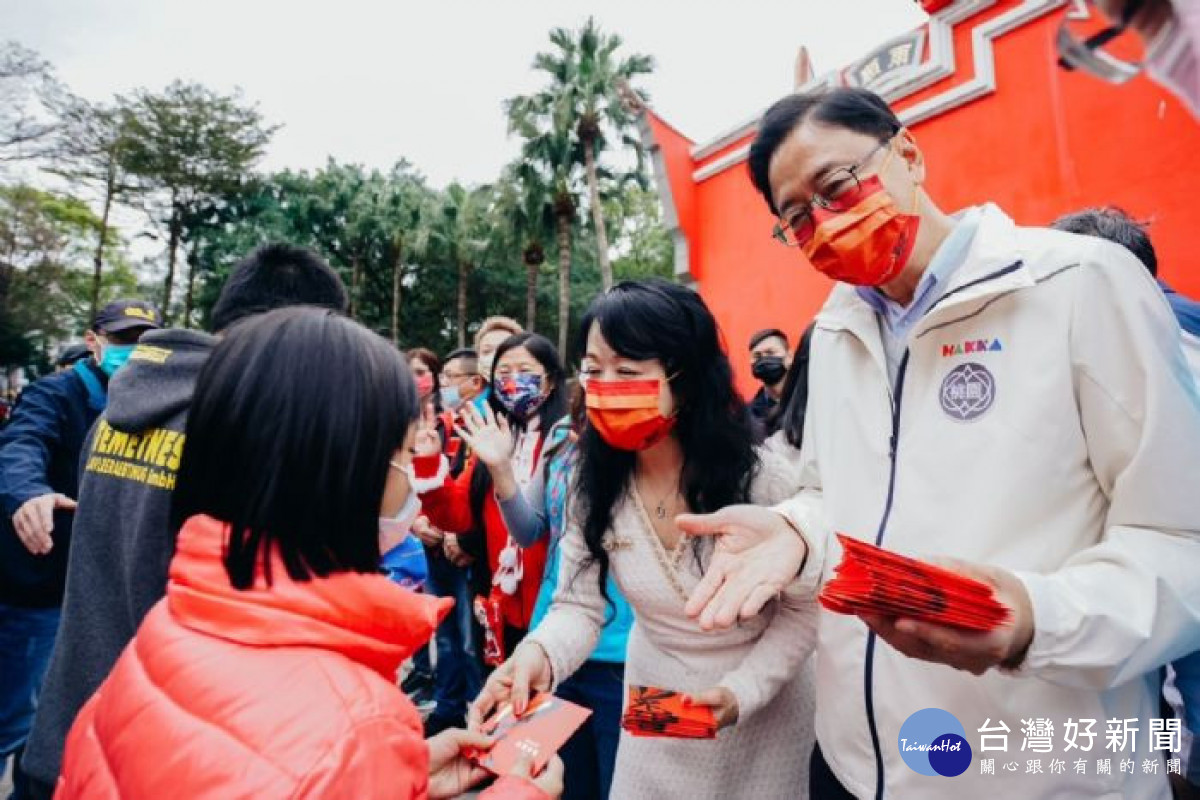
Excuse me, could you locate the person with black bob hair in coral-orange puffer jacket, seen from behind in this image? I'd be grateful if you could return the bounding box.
[56,308,560,799]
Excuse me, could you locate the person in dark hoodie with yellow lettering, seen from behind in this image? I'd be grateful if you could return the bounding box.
[22,245,348,798]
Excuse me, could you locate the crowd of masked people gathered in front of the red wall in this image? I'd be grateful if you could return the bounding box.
[0,0,1200,800]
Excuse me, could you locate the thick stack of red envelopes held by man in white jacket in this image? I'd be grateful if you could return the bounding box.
[820,534,1009,631]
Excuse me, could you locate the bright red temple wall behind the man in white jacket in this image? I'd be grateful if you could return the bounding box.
[656,0,1200,393]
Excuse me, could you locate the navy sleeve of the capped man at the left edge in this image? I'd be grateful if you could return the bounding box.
[0,380,62,517]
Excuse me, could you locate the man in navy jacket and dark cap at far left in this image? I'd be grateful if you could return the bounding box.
[0,300,161,796]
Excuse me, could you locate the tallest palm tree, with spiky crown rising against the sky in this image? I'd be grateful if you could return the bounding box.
[514,17,654,289]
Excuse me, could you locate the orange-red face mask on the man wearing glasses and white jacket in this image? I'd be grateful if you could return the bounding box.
[800,175,920,287]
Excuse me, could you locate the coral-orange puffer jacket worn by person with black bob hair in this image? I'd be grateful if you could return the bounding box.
[55,517,546,800]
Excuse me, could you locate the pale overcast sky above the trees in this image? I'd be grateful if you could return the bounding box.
[0,0,923,185]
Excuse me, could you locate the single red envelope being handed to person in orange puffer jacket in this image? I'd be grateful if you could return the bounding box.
[474,692,592,775]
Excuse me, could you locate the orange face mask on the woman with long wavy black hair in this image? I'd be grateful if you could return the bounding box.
[584,379,676,450]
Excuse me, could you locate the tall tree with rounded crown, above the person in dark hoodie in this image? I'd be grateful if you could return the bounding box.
[119,80,275,325]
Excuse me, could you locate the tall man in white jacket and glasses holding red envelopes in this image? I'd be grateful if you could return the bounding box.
[679,89,1200,800]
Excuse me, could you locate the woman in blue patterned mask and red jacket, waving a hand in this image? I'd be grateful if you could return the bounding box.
[414,333,570,664]
